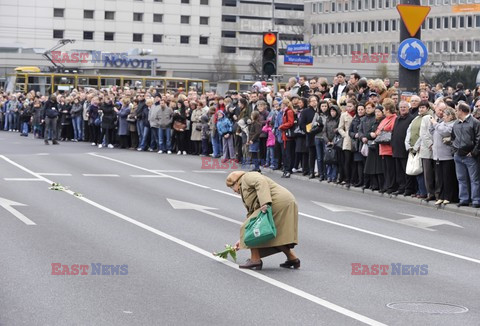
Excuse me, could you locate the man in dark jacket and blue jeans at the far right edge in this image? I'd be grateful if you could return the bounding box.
[452,102,480,208]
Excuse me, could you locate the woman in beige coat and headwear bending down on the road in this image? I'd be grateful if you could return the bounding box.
[226,171,300,270]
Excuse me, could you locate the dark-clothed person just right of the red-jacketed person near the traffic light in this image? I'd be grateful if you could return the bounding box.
[299,95,318,179]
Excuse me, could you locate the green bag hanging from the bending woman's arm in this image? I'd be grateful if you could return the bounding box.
[243,206,277,247]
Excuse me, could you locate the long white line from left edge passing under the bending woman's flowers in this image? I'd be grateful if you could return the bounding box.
[0,155,386,326]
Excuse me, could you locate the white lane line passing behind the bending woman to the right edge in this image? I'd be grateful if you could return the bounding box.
[90,153,480,264]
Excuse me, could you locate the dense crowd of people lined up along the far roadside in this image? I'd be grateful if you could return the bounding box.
[0,72,480,207]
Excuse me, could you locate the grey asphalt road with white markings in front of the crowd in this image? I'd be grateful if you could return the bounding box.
[0,132,480,325]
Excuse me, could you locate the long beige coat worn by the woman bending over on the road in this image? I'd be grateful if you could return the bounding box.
[239,172,298,249]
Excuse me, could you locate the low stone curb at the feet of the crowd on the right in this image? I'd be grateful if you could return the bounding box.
[262,168,480,217]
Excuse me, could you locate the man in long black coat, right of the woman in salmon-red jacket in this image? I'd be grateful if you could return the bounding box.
[391,101,415,196]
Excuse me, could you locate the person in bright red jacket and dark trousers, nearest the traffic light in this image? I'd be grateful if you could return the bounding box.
[278,99,295,178]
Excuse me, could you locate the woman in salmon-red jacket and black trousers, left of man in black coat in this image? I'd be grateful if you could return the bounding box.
[375,98,397,194]
